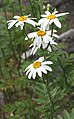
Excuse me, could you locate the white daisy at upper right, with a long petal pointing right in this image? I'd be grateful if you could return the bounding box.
[38,11,69,29]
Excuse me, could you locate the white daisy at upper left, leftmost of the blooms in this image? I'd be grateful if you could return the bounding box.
[7,14,37,30]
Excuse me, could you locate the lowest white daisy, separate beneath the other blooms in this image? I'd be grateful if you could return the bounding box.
[25,57,53,79]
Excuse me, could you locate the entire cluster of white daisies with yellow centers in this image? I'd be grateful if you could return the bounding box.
[7,11,69,79]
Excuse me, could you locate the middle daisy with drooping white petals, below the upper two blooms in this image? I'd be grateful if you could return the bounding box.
[25,29,59,55]
